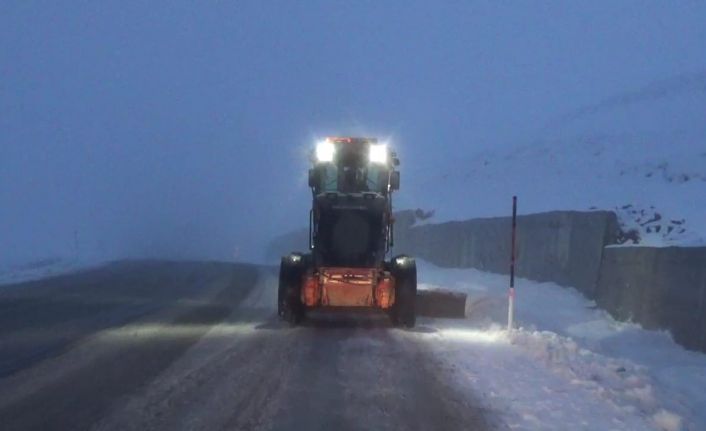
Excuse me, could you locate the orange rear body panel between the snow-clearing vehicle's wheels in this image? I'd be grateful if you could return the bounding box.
[301,267,395,310]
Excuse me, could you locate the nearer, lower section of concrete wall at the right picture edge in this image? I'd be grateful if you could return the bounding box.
[596,247,706,352]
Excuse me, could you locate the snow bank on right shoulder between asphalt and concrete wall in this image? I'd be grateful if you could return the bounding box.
[401,262,706,431]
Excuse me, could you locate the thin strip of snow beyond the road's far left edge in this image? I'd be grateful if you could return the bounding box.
[0,257,108,286]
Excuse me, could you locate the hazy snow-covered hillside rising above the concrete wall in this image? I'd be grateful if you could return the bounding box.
[399,73,706,246]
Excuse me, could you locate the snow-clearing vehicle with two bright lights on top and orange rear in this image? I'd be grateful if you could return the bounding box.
[277,137,417,327]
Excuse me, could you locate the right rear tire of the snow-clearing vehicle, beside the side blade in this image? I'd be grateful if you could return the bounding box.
[390,256,417,328]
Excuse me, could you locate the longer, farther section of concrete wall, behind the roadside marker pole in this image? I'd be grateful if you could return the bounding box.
[395,211,619,298]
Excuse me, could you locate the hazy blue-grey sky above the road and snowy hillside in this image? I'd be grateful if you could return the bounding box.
[0,0,706,262]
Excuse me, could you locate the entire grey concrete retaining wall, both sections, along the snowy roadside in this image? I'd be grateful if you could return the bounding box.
[396,211,706,352]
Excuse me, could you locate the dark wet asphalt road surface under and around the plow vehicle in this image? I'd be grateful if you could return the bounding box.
[0,261,491,431]
